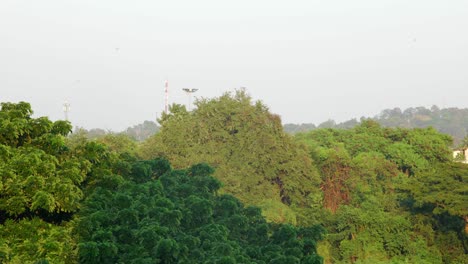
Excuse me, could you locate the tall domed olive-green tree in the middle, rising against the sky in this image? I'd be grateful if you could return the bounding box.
[141,90,320,223]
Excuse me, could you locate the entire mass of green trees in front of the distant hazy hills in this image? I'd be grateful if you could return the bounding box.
[0,90,468,263]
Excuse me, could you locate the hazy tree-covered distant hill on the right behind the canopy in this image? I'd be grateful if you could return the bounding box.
[284,106,468,146]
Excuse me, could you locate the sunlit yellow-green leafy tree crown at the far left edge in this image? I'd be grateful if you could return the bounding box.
[0,103,90,217]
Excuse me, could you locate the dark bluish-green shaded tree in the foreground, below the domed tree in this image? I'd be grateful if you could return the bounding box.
[78,161,323,263]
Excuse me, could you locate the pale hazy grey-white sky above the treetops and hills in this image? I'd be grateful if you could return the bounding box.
[0,0,468,131]
